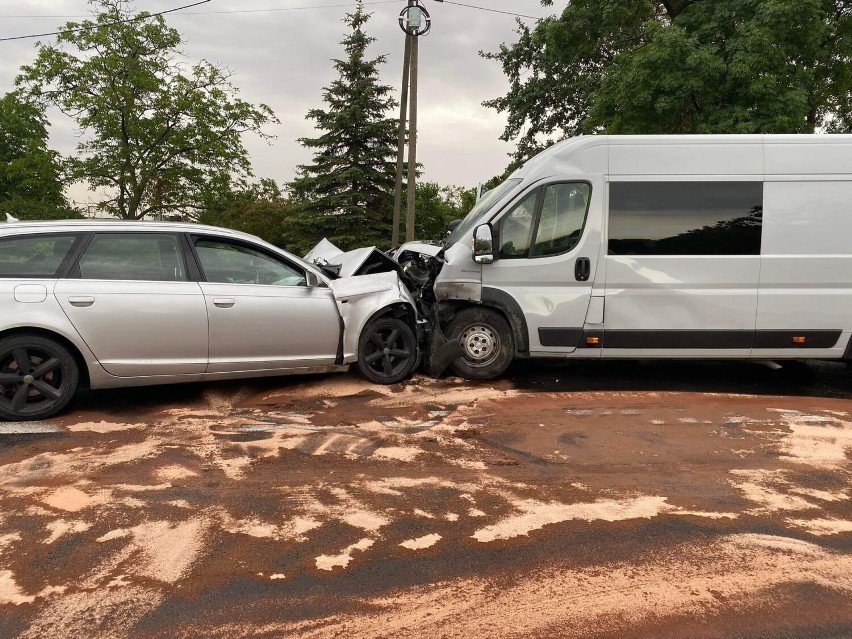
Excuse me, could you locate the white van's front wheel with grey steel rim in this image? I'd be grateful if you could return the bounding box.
[447,308,515,379]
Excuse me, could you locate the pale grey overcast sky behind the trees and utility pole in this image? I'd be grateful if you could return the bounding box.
[0,0,546,201]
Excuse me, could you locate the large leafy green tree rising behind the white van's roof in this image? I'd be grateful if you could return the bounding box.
[485,0,852,162]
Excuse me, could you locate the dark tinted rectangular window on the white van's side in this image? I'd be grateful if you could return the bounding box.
[607,182,763,255]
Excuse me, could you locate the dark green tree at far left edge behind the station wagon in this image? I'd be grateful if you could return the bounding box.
[0,93,80,221]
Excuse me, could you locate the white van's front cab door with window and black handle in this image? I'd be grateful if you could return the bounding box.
[482,180,602,354]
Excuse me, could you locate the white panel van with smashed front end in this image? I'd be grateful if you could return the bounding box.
[395,135,852,379]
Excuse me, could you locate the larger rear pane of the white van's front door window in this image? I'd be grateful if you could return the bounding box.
[530,182,591,257]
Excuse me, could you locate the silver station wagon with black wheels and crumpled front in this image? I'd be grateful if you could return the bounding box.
[0,221,421,420]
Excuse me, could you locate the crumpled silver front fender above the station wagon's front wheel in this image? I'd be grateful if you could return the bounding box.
[329,273,418,364]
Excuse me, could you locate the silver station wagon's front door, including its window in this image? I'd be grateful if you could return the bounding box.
[193,236,342,373]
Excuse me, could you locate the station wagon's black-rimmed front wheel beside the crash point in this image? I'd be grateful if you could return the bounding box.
[358,317,417,384]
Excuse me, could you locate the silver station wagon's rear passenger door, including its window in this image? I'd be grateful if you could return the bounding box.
[54,232,207,377]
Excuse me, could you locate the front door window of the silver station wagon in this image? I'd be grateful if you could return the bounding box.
[195,238,307,286]
